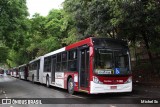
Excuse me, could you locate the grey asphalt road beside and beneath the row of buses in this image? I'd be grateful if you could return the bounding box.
[0,76,160,107]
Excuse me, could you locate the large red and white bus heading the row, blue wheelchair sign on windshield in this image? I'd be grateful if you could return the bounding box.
[39,37,132,94]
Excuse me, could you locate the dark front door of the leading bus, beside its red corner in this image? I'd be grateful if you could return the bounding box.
[79,47,89,90]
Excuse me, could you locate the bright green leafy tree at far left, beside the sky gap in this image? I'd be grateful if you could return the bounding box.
[0,0,28,66]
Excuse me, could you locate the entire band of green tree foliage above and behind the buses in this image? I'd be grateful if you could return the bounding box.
[0,0,160,69]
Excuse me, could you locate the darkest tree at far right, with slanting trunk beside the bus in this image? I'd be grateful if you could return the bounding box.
[114,0,160,69]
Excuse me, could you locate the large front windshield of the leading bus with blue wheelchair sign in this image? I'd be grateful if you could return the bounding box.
[94,48,130,75]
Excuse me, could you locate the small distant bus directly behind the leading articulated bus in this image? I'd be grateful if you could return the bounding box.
[19,64,28,80]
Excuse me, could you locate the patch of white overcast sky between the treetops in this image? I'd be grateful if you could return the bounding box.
[26,0,64,17]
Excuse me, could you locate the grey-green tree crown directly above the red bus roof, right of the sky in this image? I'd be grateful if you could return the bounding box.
[64,0,117,39]
